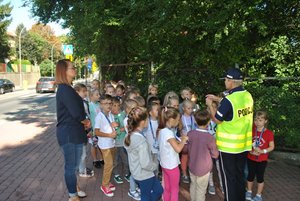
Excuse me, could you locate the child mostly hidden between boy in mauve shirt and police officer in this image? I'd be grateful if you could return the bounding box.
[207,101,224,195]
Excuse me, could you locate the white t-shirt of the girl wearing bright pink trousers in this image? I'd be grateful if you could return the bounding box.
[158,128,180,170]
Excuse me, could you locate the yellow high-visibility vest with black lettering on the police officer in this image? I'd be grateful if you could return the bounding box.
[216,90,253,153]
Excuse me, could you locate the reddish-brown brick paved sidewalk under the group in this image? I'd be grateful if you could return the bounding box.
[0,123,300,201]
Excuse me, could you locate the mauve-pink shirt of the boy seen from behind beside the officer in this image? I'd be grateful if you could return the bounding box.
[188,129,219,177]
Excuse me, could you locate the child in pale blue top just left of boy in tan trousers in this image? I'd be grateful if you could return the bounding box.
[89,89,104,168]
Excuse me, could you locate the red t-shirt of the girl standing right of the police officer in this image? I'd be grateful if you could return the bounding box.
[248,127,274,162]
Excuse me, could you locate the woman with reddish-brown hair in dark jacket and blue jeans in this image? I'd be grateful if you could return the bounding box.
[55,59,90,201]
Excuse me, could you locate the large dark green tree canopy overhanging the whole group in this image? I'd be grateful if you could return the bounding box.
[25,0,300,149]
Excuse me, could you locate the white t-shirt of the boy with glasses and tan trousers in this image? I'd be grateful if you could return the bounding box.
[95,112,115,149]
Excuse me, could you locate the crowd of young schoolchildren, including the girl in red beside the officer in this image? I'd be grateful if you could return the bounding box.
[74,80,274,201]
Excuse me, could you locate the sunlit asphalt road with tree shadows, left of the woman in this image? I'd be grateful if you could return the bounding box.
[0,90,56,150]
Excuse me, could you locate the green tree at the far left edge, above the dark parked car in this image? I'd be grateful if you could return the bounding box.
[0,0,12,62]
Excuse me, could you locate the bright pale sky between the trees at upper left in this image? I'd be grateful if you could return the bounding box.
[2,0,69,36]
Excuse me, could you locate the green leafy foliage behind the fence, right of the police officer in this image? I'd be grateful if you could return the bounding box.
[245,78,300,149]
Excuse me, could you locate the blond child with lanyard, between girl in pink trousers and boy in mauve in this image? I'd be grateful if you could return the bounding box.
[180,99,196,184]
